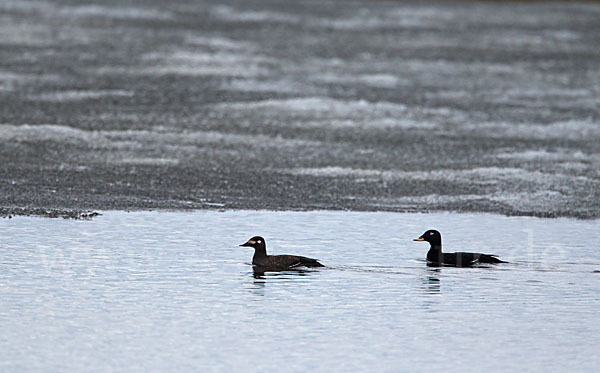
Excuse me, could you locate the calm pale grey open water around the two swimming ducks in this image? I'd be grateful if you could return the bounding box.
[0,211,600,372]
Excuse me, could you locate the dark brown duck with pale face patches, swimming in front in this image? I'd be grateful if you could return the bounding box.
[240,236,325,271]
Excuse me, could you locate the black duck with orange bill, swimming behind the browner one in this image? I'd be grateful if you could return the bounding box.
[414,230,507,267]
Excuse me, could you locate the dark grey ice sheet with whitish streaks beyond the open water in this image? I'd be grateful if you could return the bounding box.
[0,0,600,218]
